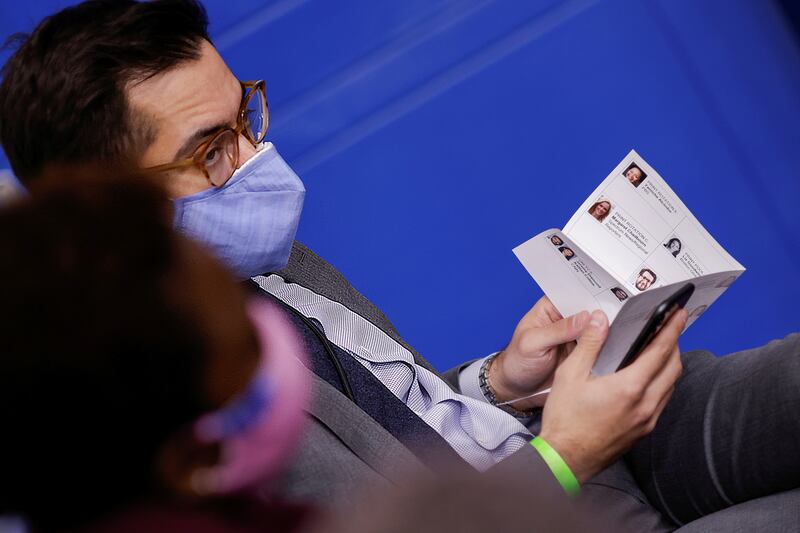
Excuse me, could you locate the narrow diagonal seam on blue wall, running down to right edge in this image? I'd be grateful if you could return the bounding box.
[645,1,800,268]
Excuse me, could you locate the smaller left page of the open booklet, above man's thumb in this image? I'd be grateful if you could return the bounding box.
[514,229,630,320]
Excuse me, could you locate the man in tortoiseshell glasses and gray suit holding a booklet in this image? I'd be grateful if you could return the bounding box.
[0,0,800,531]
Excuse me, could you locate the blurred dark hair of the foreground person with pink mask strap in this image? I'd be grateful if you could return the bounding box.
[0,176,209,529]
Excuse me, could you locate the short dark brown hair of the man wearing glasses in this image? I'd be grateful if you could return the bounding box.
[0,0,208,183]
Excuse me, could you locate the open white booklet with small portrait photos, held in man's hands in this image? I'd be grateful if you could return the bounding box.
[514,150,745,375]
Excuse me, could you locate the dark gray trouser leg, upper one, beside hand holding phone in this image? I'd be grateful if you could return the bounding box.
[627,334,800,524]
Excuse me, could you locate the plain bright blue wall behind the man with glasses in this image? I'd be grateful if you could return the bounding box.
[0,0,800,368]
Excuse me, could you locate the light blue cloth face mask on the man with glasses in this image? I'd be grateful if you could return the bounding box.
[173,143,306,279]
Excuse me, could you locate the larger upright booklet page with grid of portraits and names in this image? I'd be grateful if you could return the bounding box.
[564,150,744,295]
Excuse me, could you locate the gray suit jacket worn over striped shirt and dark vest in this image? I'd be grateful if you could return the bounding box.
[268,242,564,505]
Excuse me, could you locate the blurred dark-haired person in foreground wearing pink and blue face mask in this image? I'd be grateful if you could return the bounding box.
[0,176,309,532]
